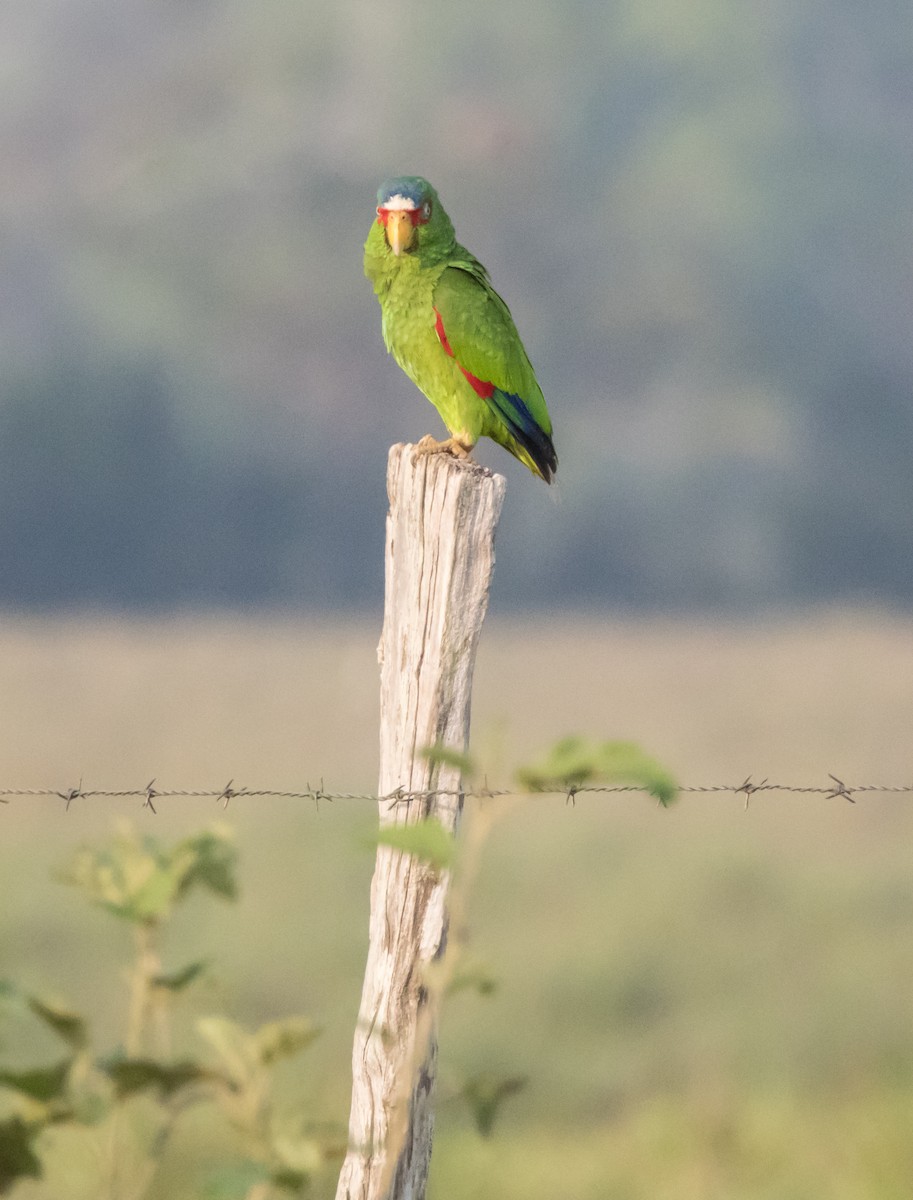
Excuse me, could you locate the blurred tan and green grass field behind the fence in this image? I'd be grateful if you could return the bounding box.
[0,611,913,1200]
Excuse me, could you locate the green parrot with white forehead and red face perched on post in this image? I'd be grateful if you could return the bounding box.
[365,175,558,484]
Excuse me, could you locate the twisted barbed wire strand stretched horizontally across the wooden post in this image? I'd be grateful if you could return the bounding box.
[0,772,913,812]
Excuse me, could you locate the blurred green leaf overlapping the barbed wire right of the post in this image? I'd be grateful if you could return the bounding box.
[517,737,678,808]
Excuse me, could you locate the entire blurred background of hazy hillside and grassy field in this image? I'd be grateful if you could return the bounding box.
[0,9,913,1200]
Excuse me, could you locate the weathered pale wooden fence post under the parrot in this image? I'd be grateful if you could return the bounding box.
[336,445,505,1200]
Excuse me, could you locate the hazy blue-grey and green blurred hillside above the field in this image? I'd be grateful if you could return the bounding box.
[0,0,913,608]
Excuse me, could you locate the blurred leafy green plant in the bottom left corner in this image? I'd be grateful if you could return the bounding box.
[0,827,338,1200]
